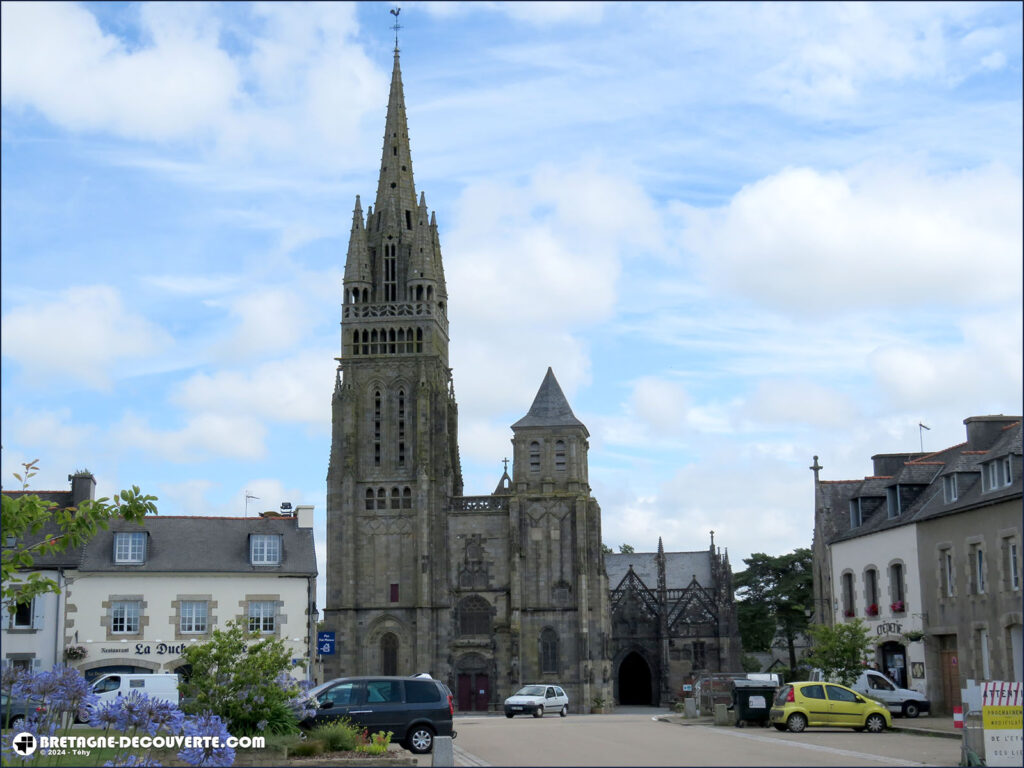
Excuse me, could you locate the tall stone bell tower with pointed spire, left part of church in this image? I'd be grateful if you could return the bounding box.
[324,43,462,678]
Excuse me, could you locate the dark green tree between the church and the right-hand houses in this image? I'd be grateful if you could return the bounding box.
[733,547,814,670]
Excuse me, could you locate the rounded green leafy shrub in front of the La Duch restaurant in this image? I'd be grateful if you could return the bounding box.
[181,622,302,735]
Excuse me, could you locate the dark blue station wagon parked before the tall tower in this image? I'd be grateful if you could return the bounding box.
[300,677,456,754]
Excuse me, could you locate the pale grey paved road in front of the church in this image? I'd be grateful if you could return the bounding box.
[420,709,959,766]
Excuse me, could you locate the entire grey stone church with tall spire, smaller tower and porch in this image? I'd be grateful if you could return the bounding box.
[324,47,739,712]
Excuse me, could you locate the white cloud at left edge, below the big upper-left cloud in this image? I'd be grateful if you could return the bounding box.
[0,286,171,388]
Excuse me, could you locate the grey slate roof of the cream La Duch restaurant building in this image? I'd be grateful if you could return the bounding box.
[79,515,316,575]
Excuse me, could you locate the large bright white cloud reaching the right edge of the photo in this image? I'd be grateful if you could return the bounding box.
[677,167,1022,313]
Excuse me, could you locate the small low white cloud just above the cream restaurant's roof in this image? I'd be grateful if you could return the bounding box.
[112,413,266,463]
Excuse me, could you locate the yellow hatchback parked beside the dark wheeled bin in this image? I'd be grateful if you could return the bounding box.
[769,682,893,733]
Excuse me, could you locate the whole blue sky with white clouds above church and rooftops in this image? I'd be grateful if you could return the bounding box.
[0,2,1024,606]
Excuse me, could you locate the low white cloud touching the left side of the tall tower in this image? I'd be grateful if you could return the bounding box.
[171,349,338,427]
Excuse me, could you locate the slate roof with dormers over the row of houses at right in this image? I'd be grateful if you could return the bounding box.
[820,421,1022,544]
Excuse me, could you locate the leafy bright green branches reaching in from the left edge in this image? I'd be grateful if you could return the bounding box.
[0,460,157,612]
